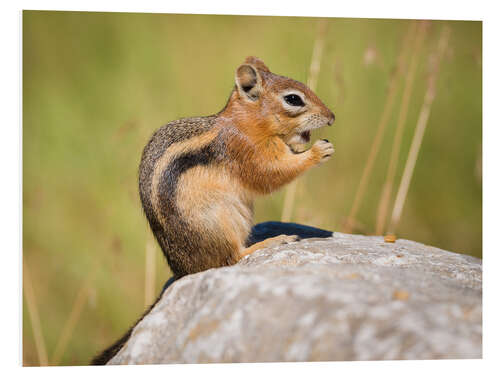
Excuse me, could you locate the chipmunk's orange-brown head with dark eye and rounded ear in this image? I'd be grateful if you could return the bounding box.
[233,57,335,145]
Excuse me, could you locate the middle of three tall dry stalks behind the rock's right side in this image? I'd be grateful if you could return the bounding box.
[375,21,429,235]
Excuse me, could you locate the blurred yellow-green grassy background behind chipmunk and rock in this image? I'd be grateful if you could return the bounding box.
[23,11,482,365]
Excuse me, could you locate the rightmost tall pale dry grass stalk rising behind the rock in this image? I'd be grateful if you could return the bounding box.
[389,26,450,233]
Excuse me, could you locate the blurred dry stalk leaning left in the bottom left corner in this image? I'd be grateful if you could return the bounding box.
[23,261,49,366]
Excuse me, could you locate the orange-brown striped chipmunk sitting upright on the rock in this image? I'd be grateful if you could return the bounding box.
[93,57,335,364]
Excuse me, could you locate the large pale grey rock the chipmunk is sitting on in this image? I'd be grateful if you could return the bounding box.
[109,223,482,364]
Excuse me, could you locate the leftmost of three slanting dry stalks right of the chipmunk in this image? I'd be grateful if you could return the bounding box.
[342,22,416,233]
